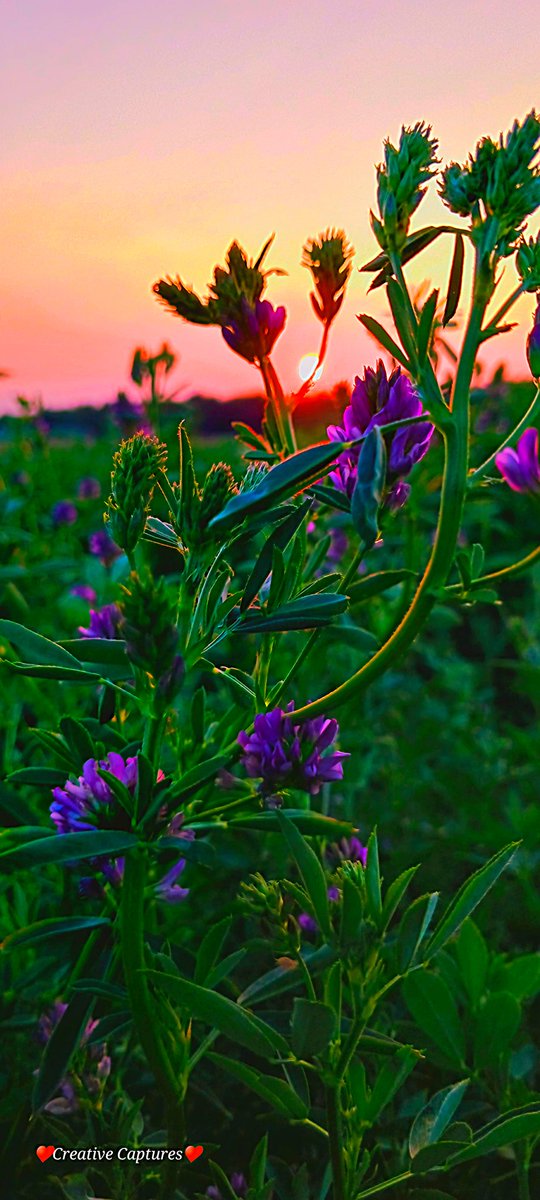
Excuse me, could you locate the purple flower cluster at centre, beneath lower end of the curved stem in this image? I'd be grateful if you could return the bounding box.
[238,701,349,796]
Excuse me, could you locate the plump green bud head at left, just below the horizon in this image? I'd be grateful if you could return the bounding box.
[106,433,167,553]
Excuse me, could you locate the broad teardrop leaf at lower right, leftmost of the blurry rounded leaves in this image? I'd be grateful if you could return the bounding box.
[403,971,466,1068]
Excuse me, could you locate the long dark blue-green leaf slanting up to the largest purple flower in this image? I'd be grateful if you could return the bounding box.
[210,442,343,530]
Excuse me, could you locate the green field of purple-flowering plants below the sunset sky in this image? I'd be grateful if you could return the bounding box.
[0,114,540,1200]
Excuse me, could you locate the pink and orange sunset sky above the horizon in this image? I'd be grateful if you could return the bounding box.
[0,0,539,412]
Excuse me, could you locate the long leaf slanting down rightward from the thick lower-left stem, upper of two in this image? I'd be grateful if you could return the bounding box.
[145,971,289,1058]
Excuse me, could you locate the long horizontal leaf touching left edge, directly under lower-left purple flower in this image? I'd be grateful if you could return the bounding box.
[1,829,137,869]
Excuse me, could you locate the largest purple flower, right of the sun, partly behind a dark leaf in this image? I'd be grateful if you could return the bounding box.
[326,360,433,508]
